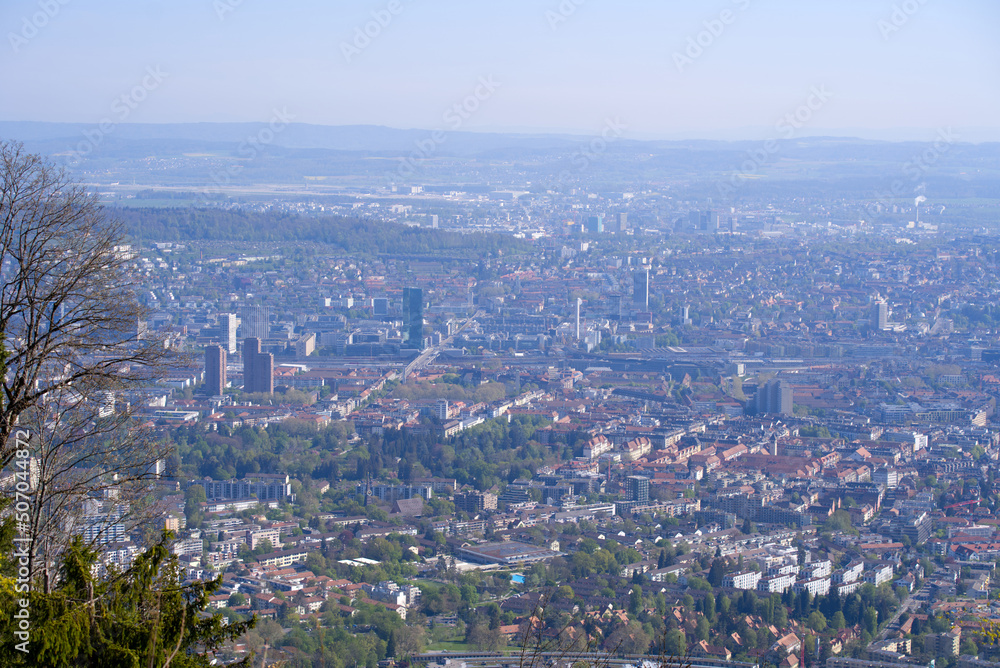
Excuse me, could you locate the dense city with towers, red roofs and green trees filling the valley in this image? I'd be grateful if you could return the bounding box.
[7,170,1000,668]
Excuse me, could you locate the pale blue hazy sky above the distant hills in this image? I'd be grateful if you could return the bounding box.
[0,0,1000,137]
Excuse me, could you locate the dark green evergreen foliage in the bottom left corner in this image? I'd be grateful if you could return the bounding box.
[0,522,256,668]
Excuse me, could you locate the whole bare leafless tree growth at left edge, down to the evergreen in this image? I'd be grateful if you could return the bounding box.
[0,142,176,575]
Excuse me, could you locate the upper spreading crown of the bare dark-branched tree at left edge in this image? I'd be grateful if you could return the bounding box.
[0,142,165,460]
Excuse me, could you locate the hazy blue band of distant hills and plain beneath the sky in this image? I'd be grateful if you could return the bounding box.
[0,122,1000,204]
